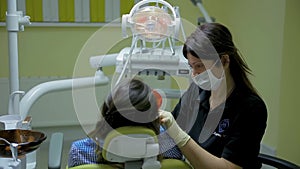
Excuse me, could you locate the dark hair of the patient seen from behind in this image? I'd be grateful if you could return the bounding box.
[89,78,159,163]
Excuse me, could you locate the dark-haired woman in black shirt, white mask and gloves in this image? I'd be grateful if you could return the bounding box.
[160,23,267,169]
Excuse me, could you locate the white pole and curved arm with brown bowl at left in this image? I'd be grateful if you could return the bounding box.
[0,0,109,169]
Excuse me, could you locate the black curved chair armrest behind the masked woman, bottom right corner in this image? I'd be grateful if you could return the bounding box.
[258,153,300,169]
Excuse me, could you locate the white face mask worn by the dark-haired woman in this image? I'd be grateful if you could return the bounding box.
[192,62,224,90]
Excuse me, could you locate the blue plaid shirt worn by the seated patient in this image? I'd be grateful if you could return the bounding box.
[68,127,183,167]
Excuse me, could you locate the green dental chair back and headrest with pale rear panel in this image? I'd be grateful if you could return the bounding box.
[67,126,192,169]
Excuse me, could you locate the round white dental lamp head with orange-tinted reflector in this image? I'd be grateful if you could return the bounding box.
[122,0,180,42]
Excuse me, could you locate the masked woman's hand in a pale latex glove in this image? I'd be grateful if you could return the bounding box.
[159,110,191,148]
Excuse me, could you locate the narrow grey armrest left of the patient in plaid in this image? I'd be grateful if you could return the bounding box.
[48,133,64,169]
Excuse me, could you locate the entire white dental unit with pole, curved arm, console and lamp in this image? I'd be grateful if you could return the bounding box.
[0,0,210,169]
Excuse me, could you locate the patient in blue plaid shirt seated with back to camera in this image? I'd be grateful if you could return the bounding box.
[68,79,182,168]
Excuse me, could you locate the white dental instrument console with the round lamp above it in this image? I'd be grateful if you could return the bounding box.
[90,0,190,84]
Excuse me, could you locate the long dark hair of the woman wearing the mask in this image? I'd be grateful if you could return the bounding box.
[183,23,258,95]
